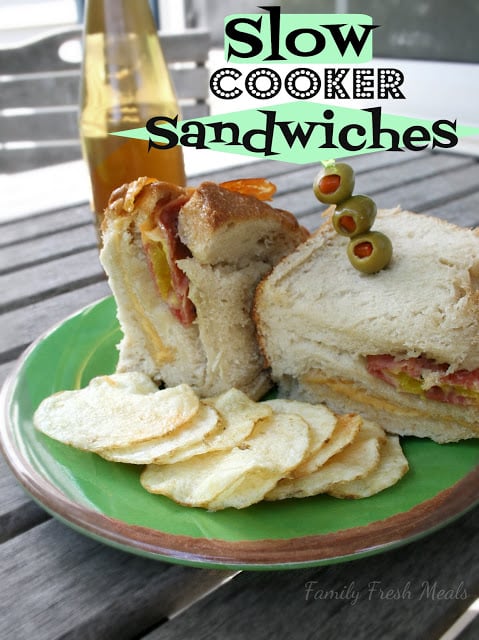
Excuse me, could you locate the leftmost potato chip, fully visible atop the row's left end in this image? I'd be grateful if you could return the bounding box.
[34,372,200,452]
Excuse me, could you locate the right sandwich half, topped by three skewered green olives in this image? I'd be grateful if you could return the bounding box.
[254,208,479,443]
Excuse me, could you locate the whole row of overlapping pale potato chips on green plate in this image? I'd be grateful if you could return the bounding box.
[34,372,408,511]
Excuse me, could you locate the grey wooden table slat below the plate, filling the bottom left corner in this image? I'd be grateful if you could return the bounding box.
[0,520,238,640]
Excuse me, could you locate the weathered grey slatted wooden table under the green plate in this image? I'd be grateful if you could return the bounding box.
[0,152,479,640]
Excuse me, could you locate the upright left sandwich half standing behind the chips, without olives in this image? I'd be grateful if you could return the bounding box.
[100,178,309,399]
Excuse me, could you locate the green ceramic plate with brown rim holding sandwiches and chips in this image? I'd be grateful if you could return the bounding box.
[1,298,479,569]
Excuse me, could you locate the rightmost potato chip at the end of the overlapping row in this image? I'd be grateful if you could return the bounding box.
[328,435,409,498]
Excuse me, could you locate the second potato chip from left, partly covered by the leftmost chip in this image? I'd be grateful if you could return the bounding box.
[98,403,220,464]
